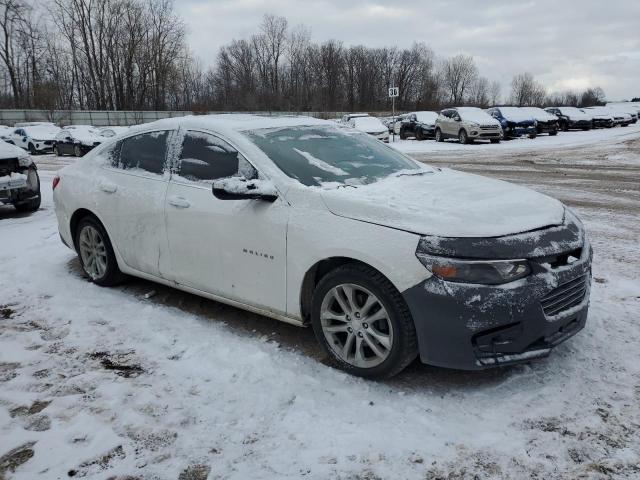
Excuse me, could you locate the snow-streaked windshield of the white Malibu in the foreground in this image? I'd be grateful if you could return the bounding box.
[245,125,420,186]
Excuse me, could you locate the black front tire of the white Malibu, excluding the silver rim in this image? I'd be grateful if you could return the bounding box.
[311,264,418,378]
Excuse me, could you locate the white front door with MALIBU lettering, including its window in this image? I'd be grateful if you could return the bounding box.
[166,131,289,312]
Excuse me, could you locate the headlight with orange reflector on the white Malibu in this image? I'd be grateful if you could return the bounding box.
[416,252,531,285]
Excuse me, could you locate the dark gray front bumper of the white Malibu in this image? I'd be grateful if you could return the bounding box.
[403,215,592,370]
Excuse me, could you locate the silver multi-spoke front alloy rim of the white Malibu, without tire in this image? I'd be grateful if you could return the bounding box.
[320,283,393,368]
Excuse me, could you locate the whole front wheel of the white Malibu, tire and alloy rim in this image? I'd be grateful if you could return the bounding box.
[311,264,418,378]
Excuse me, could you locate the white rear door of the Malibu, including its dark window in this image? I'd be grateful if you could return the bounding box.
[97,130,171,276]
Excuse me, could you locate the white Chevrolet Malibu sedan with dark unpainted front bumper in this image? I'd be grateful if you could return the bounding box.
[53,115,592,377]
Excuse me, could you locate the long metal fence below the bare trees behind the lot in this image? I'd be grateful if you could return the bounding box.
[0,110,391,127]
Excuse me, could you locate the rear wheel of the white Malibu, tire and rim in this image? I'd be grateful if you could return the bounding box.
[75,216,123,287]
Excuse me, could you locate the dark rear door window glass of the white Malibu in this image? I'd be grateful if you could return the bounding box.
[111,131,169,174]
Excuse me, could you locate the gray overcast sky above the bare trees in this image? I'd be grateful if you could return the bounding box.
[175,0,640,100]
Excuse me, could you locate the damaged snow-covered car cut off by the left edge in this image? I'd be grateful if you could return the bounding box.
[0,140,41,212]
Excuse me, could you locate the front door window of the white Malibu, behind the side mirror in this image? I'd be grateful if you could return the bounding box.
[179,131,257,181]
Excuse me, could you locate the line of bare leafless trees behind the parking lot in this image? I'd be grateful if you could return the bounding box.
[0,0,605,111]
